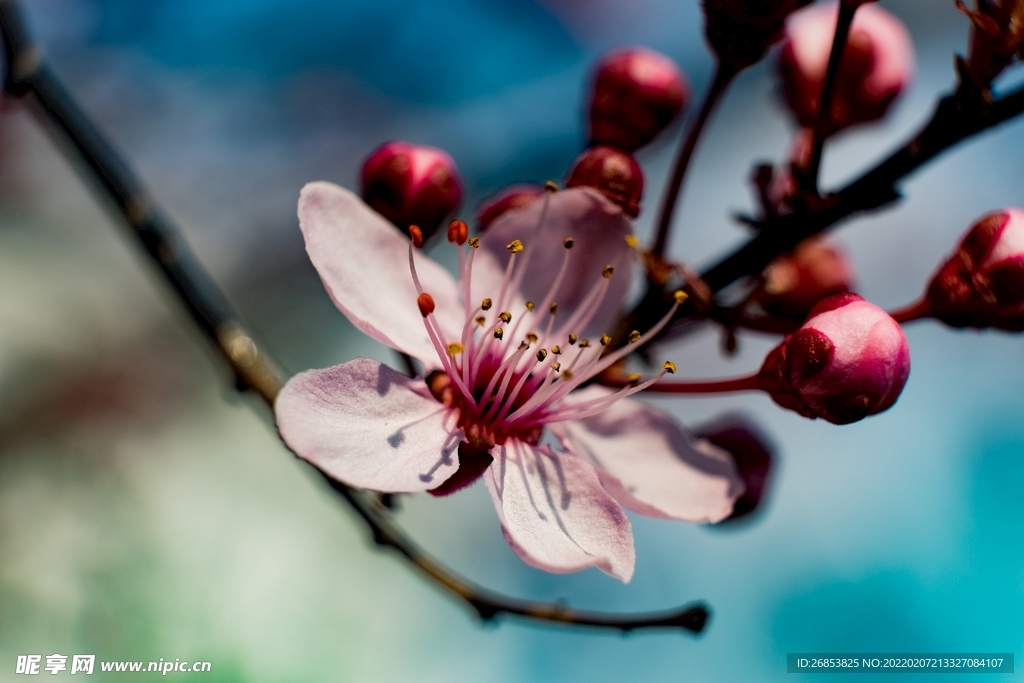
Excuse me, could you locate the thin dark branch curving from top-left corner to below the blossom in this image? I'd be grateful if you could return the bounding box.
[0,0,708,633]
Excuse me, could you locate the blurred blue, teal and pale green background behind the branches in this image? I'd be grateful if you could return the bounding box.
[0,0,1024,683]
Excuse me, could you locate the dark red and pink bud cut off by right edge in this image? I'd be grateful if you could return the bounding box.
[926,208,1024,330]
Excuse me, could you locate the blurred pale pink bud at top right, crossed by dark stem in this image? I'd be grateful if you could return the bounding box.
[779,2,913,133]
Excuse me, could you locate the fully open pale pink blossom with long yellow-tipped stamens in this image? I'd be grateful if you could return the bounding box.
[275,182,742,581]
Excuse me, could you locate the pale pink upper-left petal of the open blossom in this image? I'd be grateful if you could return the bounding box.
[299,182,463,367]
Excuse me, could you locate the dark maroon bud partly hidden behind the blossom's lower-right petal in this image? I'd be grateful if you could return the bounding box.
[693,415,775,523]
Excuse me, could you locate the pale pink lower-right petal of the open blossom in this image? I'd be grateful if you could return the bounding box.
[553,387,743,522]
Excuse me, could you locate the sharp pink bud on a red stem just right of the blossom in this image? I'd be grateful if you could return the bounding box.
[759,293,910,425]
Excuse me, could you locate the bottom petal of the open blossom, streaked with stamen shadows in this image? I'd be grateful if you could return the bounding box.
[483,440,636,583]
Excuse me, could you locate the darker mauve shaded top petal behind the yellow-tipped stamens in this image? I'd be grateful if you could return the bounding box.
[473,187,633,334]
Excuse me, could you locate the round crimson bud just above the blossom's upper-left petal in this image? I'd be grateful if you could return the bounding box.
[362,141,462,240]
